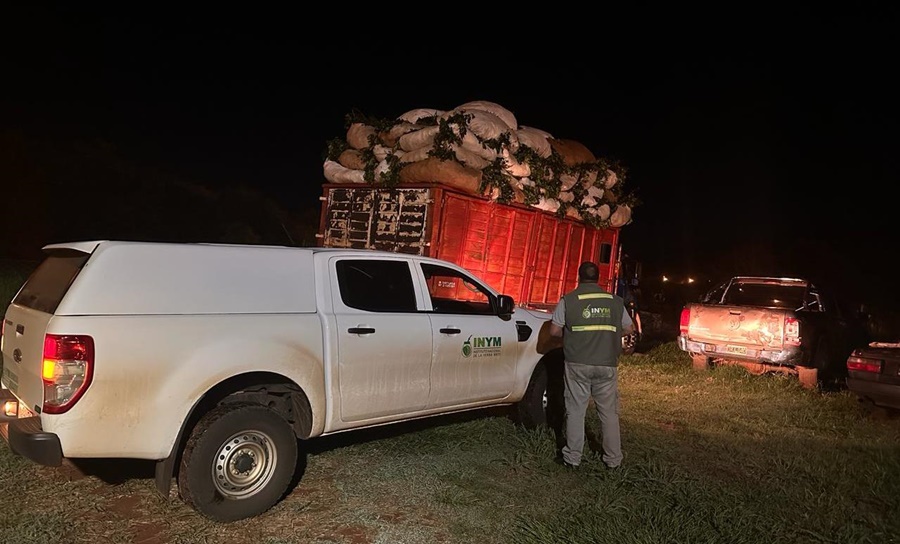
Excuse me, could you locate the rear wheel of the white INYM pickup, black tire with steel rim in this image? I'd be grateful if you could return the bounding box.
[178,403,298,522]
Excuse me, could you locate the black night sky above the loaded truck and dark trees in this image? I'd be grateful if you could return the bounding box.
[0,8,900,302]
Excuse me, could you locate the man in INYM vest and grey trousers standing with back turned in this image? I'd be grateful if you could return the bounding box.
[550,261,634,468]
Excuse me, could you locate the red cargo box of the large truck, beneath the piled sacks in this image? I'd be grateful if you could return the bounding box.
[317,183,620,311]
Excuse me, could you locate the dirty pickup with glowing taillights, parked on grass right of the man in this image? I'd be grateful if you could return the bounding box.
[678,276,866,388]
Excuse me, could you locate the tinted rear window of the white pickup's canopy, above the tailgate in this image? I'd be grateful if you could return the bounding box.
[13,250,90,314]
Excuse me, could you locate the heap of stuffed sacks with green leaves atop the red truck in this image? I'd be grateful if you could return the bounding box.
[323,100,636,227]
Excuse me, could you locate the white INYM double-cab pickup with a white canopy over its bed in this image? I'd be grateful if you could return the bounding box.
[0,241,562,522]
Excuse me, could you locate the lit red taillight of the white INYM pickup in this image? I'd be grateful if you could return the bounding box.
[41,334,94,414]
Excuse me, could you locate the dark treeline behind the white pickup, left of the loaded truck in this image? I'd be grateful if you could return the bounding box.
[0,131,318,259]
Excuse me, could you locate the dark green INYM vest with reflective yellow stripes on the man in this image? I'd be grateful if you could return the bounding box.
[563,283,625,366]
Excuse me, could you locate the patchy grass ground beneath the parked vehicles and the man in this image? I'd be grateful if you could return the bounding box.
[0,343,900,544]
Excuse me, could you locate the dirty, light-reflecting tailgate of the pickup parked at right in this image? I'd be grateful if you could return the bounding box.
[688,304,785,355]
